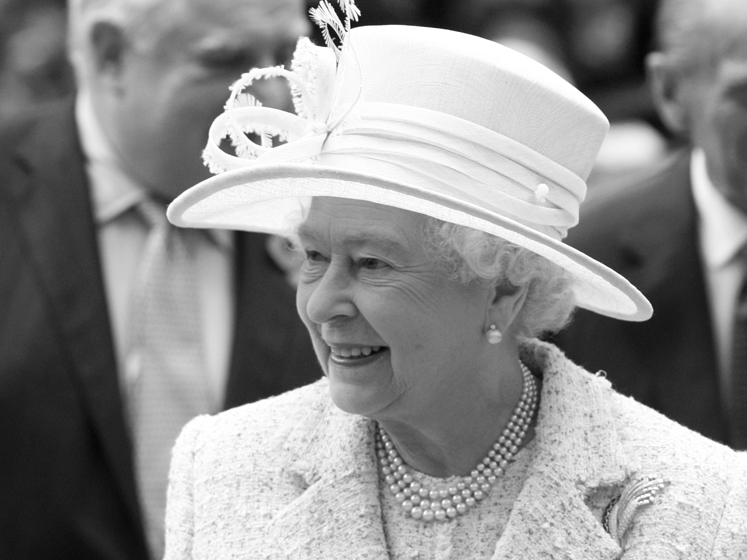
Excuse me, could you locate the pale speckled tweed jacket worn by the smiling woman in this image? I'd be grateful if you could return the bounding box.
[166,341,747,560]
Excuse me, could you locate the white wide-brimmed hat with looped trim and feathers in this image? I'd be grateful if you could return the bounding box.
[168,2,652,321]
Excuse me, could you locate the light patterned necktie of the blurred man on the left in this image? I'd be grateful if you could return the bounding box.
[127,200,213,558]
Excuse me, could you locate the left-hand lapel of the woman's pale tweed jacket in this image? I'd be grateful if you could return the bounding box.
[269,399,389,560]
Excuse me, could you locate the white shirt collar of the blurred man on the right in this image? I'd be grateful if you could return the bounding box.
[690,148,747,269]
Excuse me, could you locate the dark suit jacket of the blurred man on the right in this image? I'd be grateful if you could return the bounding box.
[556,152,728,442]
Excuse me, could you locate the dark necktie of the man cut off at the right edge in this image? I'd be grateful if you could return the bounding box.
[730,248,747,450]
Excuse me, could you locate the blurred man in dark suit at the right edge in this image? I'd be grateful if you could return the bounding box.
[561,0,747,449]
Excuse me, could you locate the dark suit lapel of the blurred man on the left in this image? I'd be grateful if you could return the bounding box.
[10,102,140,524]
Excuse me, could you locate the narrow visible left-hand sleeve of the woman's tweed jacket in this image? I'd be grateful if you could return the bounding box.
[164,416,210,560]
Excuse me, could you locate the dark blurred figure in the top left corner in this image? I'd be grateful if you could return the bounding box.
[0,0,73,122]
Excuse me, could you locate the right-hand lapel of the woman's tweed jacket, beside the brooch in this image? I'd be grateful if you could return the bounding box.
[493,345,628,560]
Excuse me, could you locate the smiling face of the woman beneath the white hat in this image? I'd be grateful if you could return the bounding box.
[297,198,496,421]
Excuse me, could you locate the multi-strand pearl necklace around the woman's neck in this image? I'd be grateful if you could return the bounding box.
[376,364,537,521]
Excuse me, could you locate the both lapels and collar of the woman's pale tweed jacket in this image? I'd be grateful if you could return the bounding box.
[270,342,627,560]
